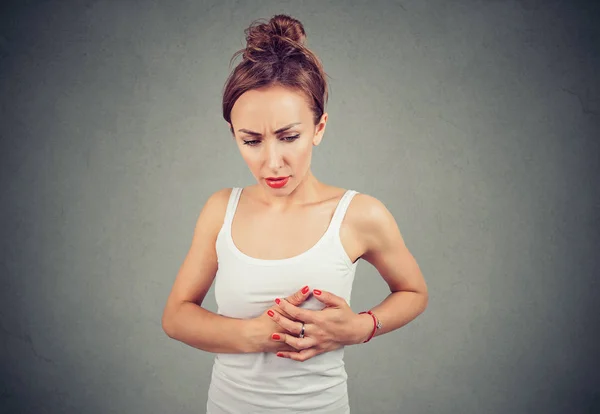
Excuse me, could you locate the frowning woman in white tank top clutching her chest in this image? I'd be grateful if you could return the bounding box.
[162,15,427,414]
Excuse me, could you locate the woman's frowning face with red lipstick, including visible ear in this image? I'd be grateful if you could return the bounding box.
[230,86,327,195]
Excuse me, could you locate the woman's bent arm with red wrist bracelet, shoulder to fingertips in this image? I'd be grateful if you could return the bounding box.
[274,194,428,361]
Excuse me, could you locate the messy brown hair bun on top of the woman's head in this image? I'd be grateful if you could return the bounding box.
[244,14,306,61]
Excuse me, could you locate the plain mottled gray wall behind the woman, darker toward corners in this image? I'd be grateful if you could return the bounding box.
[0,0,600,414]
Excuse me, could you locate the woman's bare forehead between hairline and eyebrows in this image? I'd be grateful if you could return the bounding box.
[231,86,311,123]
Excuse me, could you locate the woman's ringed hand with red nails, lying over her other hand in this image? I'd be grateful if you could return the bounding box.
[271,289,373,361]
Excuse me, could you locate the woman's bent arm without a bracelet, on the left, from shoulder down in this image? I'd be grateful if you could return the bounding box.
[162,189,305,353]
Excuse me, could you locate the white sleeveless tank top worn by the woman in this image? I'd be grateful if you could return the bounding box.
[207,188,358,414]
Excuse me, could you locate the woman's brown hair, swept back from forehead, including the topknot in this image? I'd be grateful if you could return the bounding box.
[223,14,328,133]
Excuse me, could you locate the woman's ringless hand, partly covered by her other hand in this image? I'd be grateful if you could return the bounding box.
[246,286,310,352]
